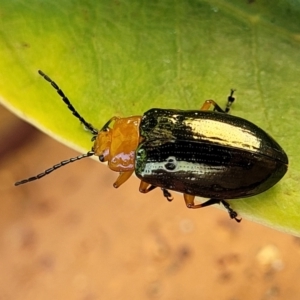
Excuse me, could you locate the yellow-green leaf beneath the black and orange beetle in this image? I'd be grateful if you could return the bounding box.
[0,0,300,235]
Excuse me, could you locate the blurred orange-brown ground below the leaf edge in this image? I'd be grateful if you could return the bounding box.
[0,109,300,300]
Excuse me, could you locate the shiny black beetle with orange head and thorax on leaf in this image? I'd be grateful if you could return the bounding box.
[15,70,288,222]
